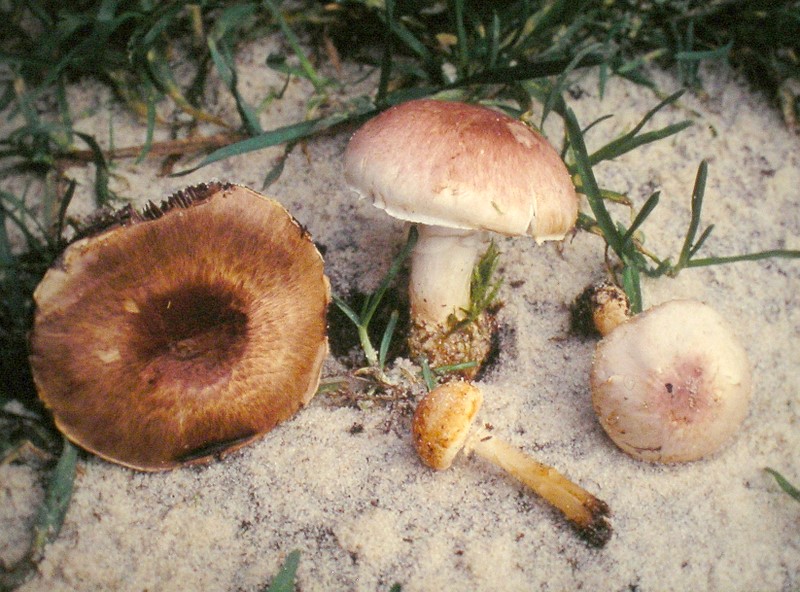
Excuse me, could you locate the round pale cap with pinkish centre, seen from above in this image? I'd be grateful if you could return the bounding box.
[591,300,751,462]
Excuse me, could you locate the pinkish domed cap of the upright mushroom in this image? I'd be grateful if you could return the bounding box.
[344,99,578,242]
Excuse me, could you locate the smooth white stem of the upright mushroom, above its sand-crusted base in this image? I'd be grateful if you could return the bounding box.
[409,224,484,324]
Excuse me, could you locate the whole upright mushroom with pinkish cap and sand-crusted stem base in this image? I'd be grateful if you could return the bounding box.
[344,99,578,372]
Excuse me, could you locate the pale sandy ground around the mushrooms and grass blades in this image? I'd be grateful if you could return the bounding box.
[0,33,800,592]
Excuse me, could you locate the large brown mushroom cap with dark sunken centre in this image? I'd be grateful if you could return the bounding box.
[30,183,330,471]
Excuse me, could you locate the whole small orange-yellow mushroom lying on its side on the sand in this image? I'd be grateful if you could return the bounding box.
[412,381,611,547]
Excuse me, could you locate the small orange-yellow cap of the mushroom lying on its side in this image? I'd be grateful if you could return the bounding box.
[411,381,483,470]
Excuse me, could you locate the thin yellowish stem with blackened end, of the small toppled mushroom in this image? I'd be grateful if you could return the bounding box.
[464,429,611,547]
